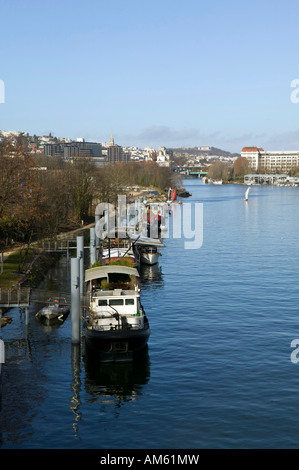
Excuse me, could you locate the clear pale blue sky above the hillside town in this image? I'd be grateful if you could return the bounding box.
[0,0,299,152]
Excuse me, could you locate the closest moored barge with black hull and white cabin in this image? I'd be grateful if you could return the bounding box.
[85,265,150,362]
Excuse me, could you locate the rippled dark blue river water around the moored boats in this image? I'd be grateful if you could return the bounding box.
[0,180,299,449]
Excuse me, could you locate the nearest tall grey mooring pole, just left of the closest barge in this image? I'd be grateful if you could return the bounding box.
[71,258,81,344]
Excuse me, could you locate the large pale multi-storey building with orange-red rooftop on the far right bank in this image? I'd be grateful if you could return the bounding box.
[241,147,299,173]
